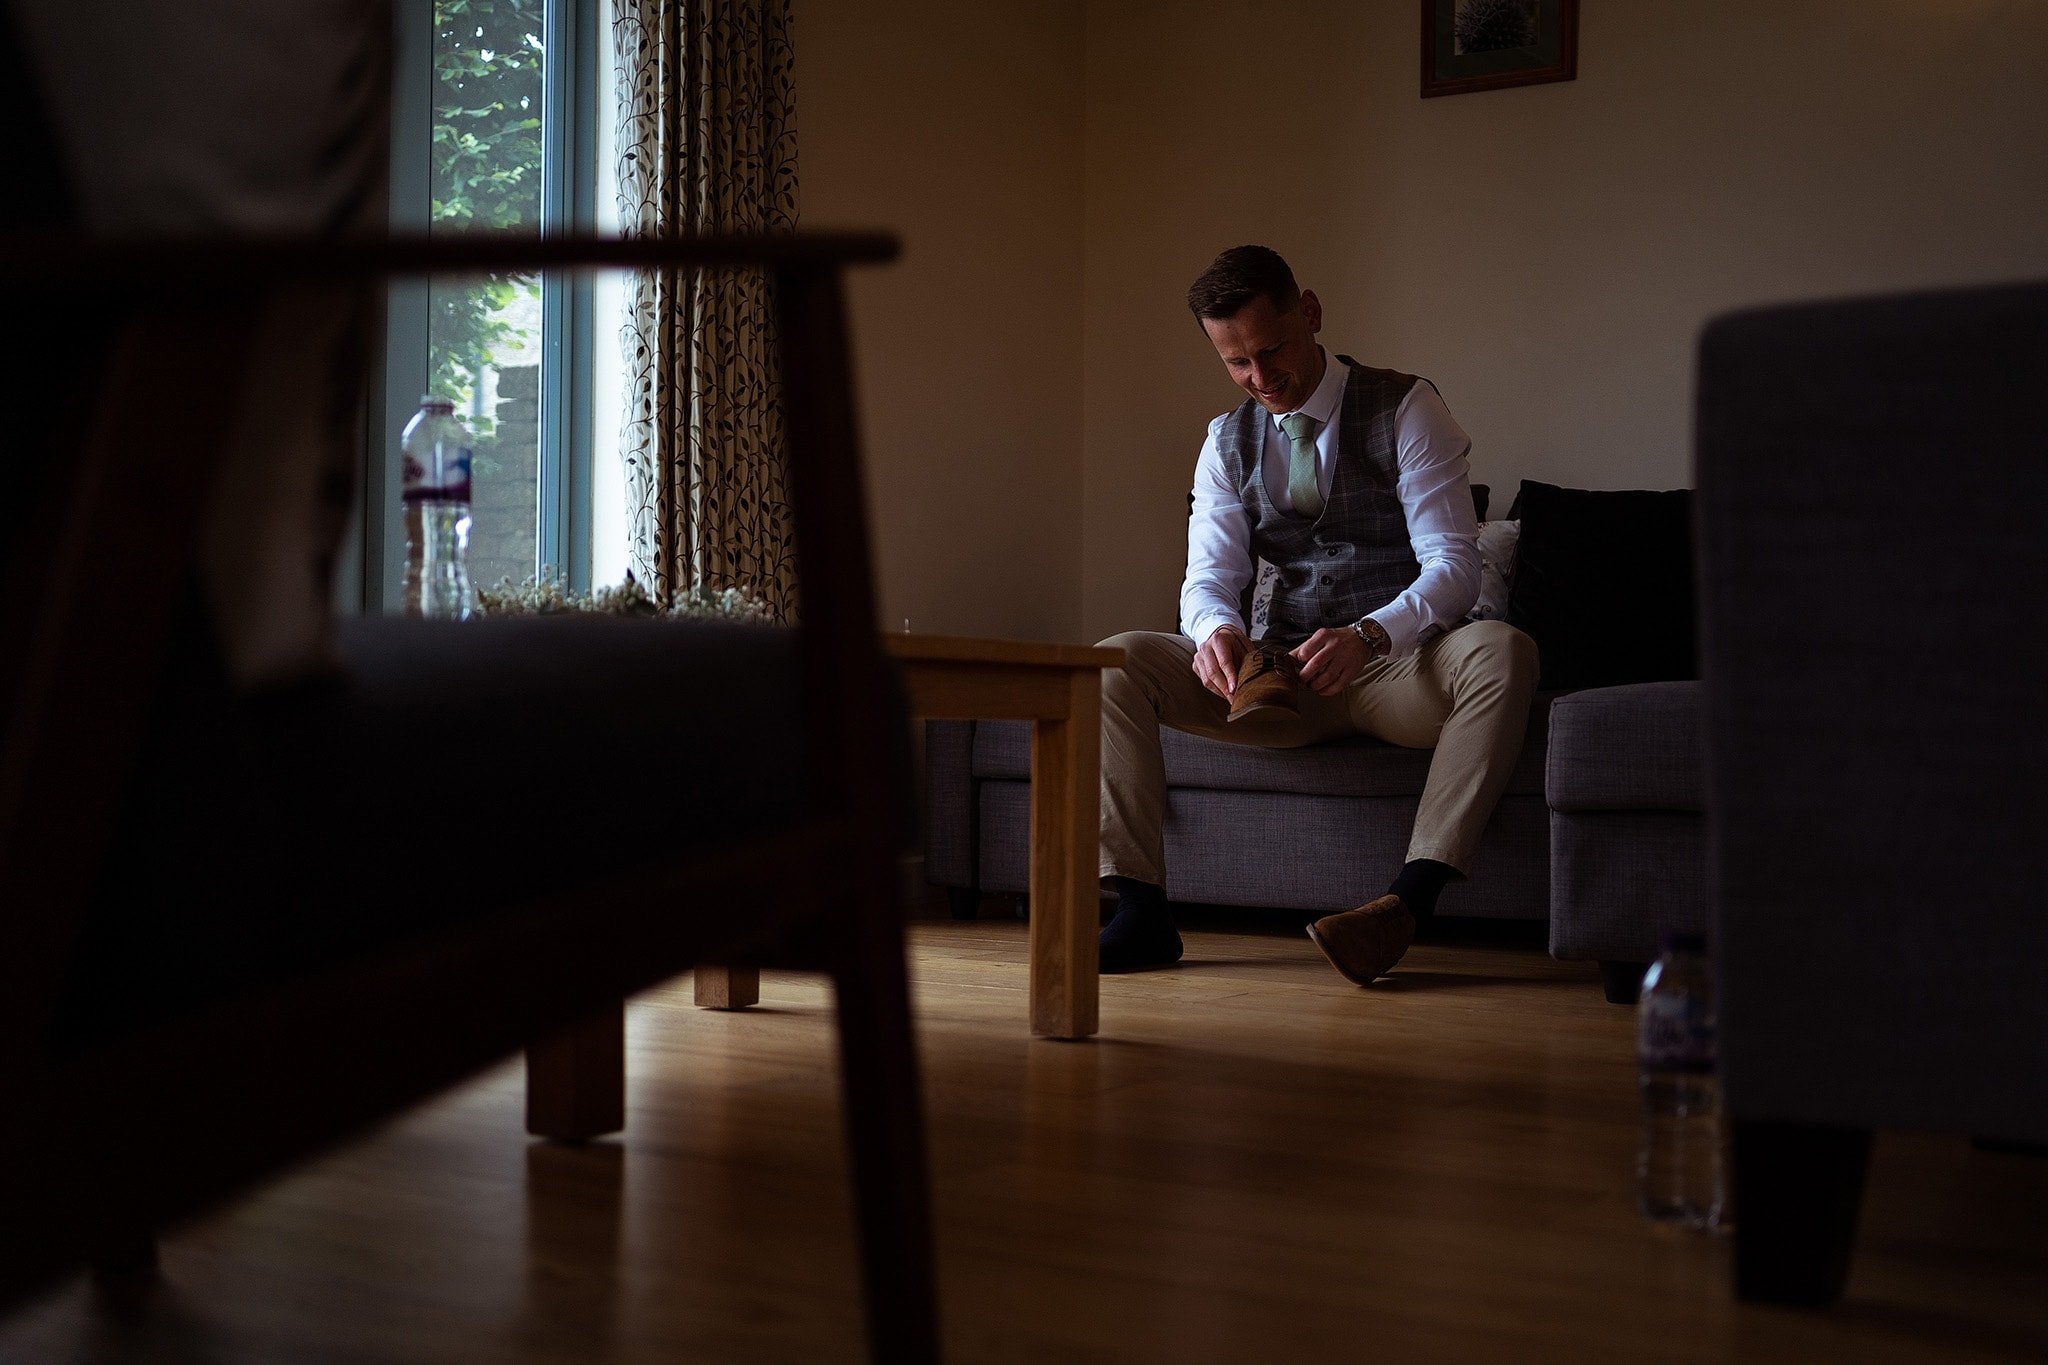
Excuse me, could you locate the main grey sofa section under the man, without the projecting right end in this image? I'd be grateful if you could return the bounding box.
[926,694,1554,919]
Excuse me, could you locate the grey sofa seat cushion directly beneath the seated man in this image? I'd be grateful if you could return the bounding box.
[975,694,1550,796]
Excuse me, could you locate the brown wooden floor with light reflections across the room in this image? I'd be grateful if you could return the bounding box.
[0,919,2048,1365]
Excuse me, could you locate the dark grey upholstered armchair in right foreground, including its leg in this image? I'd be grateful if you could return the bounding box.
[1698,284,2048,1304]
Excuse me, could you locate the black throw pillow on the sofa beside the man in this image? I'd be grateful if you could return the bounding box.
[1507,479,1700,690]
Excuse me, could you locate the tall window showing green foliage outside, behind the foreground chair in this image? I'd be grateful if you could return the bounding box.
[356,0,623,610]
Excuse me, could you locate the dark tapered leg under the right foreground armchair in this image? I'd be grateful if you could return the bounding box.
[1735,1121,1870,1308]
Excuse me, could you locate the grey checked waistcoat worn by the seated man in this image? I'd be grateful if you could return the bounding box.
[1217,356,1427,643]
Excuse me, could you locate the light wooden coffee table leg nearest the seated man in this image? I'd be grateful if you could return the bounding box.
[1030,669,1102,1038]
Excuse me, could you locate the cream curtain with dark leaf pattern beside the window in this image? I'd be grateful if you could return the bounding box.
[612,0,797,618]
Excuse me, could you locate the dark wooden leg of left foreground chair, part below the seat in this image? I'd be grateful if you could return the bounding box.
[834,859,938,1361]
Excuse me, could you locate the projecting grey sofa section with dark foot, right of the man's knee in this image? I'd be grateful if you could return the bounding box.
[1544,681,1706,1005]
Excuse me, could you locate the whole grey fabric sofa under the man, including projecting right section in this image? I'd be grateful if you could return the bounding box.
[926,497,1706,957]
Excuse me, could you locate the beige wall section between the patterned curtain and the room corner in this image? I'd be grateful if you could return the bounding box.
[795,0,1083,639]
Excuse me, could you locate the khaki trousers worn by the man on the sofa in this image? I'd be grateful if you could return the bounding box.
[1102,620,1536,886]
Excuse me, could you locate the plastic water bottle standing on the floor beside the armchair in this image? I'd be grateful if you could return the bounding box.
[1636,933,1722,1228]
